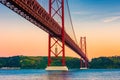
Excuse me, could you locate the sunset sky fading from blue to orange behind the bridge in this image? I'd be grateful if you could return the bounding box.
[0,0,120,59]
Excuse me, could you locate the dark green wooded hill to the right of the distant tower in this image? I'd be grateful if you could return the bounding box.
[90,56,120,69]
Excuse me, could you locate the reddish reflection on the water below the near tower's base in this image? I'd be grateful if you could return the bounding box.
[47,71,70,80]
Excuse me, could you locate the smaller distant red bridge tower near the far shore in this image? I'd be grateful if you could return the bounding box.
[80,37,88,69]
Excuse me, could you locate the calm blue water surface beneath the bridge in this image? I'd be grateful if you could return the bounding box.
[0,69,120,80]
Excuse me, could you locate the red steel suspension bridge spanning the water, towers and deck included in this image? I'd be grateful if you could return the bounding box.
[0,0,88,70]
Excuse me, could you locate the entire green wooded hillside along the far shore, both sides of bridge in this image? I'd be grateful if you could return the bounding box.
[0,56,120,69]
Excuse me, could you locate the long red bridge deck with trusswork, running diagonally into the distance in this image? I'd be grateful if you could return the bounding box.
[0,0,88,62]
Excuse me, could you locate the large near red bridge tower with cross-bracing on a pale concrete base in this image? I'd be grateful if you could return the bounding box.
[46,0,68,70]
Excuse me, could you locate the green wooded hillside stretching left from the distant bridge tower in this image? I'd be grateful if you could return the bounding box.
[0,56,80,69]
